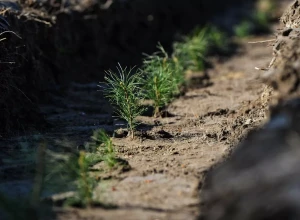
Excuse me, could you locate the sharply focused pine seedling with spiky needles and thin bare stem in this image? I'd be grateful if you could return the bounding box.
[104,65,144,138]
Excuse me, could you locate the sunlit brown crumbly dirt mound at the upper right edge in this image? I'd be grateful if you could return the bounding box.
[264,1,300,101]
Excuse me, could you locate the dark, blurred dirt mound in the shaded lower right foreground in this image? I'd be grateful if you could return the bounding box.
[202,99,300,220]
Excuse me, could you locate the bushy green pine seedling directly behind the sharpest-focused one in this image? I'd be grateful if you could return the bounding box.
[141,45,178,117]
